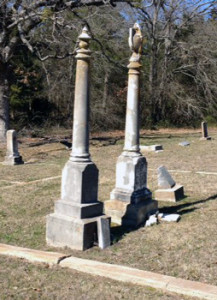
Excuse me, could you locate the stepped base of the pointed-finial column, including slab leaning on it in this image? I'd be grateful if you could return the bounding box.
[46,161,110,250]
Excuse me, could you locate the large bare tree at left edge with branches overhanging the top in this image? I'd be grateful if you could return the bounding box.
[0,0,131,141]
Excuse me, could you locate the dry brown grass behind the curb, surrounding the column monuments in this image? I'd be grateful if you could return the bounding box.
[0,131,217,299]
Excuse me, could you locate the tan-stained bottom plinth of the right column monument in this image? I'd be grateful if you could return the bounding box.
[104,199,158,228]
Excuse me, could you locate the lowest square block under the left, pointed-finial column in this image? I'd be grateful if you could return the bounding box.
[46,213,109,251]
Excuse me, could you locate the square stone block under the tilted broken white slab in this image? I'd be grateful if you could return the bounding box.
[154,184,185,202]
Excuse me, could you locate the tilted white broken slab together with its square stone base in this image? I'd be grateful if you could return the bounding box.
[154,166,184,202]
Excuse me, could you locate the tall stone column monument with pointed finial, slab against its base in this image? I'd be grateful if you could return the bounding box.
[46,27,110,250]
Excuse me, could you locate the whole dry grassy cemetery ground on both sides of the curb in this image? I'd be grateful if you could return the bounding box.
[0,128,217,299]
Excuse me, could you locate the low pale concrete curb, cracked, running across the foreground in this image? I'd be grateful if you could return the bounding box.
[0,244,217,300]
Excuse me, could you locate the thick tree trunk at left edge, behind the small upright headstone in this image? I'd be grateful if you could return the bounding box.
[0,62,9,142]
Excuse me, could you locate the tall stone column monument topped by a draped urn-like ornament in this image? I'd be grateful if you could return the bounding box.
[105,23,157,227]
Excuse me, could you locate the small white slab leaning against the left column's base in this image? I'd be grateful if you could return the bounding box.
[97,217,111,249]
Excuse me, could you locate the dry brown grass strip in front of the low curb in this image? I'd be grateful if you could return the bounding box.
[0,257,193,300]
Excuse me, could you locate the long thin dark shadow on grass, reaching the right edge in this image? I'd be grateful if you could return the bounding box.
[159,194,217,215]
